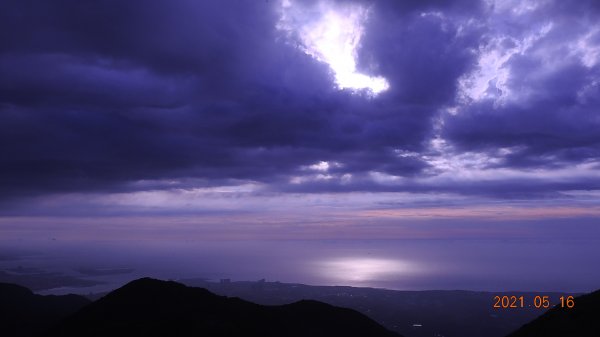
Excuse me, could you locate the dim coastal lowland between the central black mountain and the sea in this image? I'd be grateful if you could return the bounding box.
[181,279,565,337]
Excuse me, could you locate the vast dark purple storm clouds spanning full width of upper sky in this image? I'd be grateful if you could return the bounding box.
[0,0,600,198]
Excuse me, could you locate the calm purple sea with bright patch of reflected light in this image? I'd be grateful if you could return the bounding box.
[0,239,600,294]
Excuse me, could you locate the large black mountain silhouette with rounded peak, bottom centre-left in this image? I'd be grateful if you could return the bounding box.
[46,278,400,337]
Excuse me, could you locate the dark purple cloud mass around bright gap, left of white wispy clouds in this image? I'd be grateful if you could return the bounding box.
[0,0,482,196]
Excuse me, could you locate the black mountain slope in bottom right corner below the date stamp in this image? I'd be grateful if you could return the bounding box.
[507,290,600,337]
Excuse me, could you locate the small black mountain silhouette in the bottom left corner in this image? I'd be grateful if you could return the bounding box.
[0,283,90,337]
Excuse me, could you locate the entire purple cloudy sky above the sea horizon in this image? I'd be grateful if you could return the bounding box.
[0,0,600,290]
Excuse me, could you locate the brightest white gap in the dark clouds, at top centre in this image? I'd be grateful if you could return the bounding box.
[277,0,389,96]
